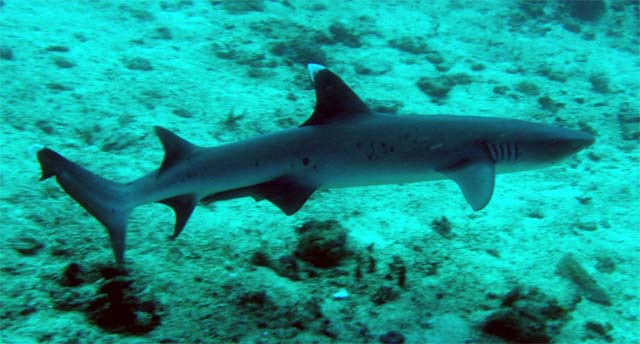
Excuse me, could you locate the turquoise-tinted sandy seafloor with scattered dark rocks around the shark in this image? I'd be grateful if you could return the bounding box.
[0,0,640,343]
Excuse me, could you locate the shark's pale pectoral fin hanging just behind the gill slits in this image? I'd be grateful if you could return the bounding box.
[440,160,496,211]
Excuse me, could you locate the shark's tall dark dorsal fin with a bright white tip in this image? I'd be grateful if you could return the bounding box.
[302,64,371,126]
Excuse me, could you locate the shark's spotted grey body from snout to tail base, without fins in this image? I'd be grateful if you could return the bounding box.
[138,113,593,202]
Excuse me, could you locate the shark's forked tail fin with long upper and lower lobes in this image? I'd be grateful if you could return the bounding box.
[38,148,131,264]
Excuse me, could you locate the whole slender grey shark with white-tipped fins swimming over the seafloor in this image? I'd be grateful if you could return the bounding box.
[37,64,595,264]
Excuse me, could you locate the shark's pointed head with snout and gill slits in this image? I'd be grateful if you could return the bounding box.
[496,123,595,170]
